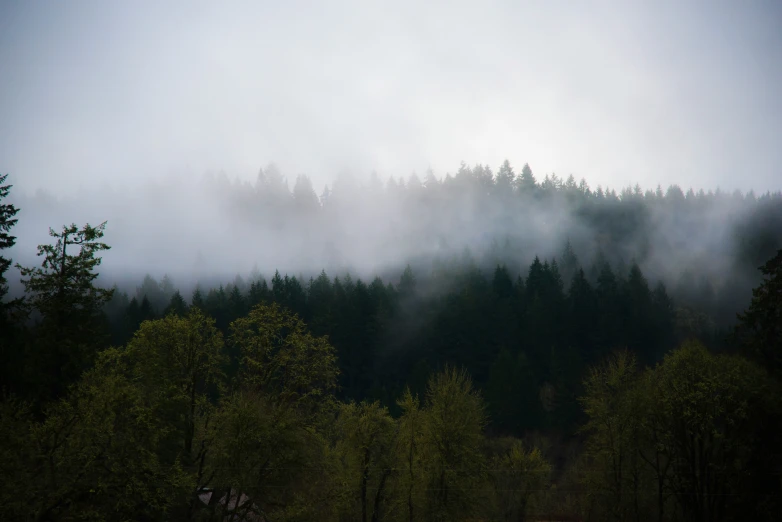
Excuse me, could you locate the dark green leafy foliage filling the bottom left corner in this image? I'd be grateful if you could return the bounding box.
[0,358,193,521]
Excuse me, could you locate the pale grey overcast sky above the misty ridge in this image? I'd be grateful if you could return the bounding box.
[0,0,782,197]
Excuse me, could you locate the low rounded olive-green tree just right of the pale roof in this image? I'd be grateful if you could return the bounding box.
[199,390,330,520]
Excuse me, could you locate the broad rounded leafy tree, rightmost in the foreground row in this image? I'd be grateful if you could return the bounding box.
[655,342,780,521]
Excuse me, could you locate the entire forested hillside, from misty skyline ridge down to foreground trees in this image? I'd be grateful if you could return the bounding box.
[0,161,782,522]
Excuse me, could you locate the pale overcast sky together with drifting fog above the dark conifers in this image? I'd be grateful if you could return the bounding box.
[0,1,782,304]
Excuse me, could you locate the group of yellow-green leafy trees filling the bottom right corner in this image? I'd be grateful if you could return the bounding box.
[582,342,780,521]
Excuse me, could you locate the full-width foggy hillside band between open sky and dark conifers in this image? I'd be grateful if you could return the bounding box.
[11,162,782,320]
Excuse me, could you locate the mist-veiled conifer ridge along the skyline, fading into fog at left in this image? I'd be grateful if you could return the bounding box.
[225,160,782,306]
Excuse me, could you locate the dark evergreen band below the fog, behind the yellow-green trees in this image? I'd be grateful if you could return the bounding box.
[104,245,692,435]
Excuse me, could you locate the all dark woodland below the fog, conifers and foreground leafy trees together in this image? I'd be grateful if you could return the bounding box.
[0,172,782,521]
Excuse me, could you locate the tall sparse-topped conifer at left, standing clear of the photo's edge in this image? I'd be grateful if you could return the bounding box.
[17,222,113,398]
